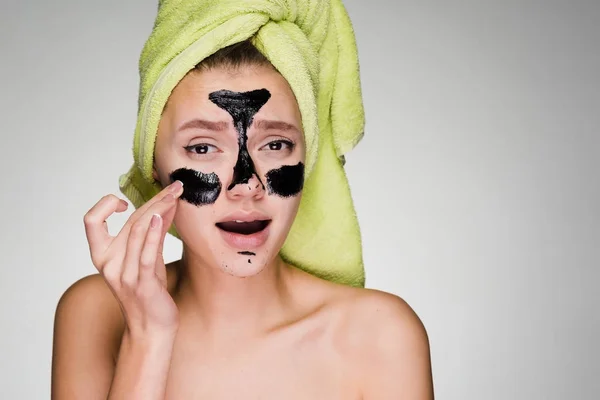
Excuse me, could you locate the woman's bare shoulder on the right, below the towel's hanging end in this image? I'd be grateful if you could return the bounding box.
[326,288,433,400]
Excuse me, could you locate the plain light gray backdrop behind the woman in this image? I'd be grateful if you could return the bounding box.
[0,0,600,399]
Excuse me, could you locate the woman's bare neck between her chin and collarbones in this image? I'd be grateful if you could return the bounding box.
[174,250,295,339]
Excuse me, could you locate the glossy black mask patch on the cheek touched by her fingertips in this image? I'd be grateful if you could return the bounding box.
[169,168,221,206]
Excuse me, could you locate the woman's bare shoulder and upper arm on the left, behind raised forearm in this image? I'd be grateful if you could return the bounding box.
[52,267,180,399]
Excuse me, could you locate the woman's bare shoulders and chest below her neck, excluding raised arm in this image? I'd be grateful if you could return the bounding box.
[53,263,433,400]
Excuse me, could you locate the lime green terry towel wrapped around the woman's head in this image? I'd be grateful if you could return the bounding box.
[119,0,365,287]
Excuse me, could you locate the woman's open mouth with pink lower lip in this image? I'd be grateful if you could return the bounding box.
[215,219,271,250]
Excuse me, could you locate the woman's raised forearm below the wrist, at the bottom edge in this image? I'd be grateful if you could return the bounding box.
[108,334,175,400]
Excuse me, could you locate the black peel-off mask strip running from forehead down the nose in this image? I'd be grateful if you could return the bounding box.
[208,89,271,190]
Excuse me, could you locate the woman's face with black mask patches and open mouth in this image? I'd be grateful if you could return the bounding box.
[155,66,305,276]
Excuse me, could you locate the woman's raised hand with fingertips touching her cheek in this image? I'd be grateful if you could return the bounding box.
[84,181,183,340]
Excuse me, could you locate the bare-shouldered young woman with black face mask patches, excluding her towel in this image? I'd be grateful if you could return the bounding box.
[52,3,433,400]
